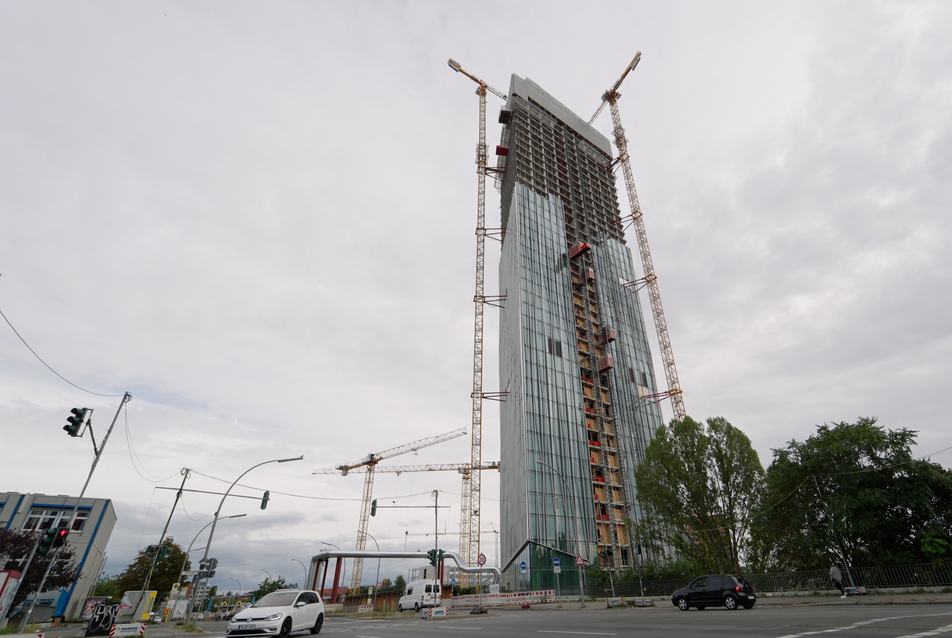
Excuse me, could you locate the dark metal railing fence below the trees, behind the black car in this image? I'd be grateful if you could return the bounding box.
[586,563,952,597]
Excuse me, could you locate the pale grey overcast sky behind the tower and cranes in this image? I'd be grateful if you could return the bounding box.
[0,1,952,590]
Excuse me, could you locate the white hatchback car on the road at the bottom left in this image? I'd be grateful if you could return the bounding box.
[225,589,324,638]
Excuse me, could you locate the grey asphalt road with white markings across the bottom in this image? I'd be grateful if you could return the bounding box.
[167,604,952,638]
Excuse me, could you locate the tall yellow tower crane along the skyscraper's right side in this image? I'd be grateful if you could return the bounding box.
[588,51,686,419]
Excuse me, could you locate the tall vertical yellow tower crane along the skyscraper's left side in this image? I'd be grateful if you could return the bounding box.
[447,58,508,583]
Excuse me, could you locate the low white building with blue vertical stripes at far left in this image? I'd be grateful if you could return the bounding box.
[0,492,116,619]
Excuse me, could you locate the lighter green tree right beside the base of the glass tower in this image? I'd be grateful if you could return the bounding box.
[632,417,764,573]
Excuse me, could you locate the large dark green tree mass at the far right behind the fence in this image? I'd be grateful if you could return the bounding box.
[756,418,952,570]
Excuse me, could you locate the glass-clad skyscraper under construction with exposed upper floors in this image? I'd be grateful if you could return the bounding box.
[497,75,662,588]
